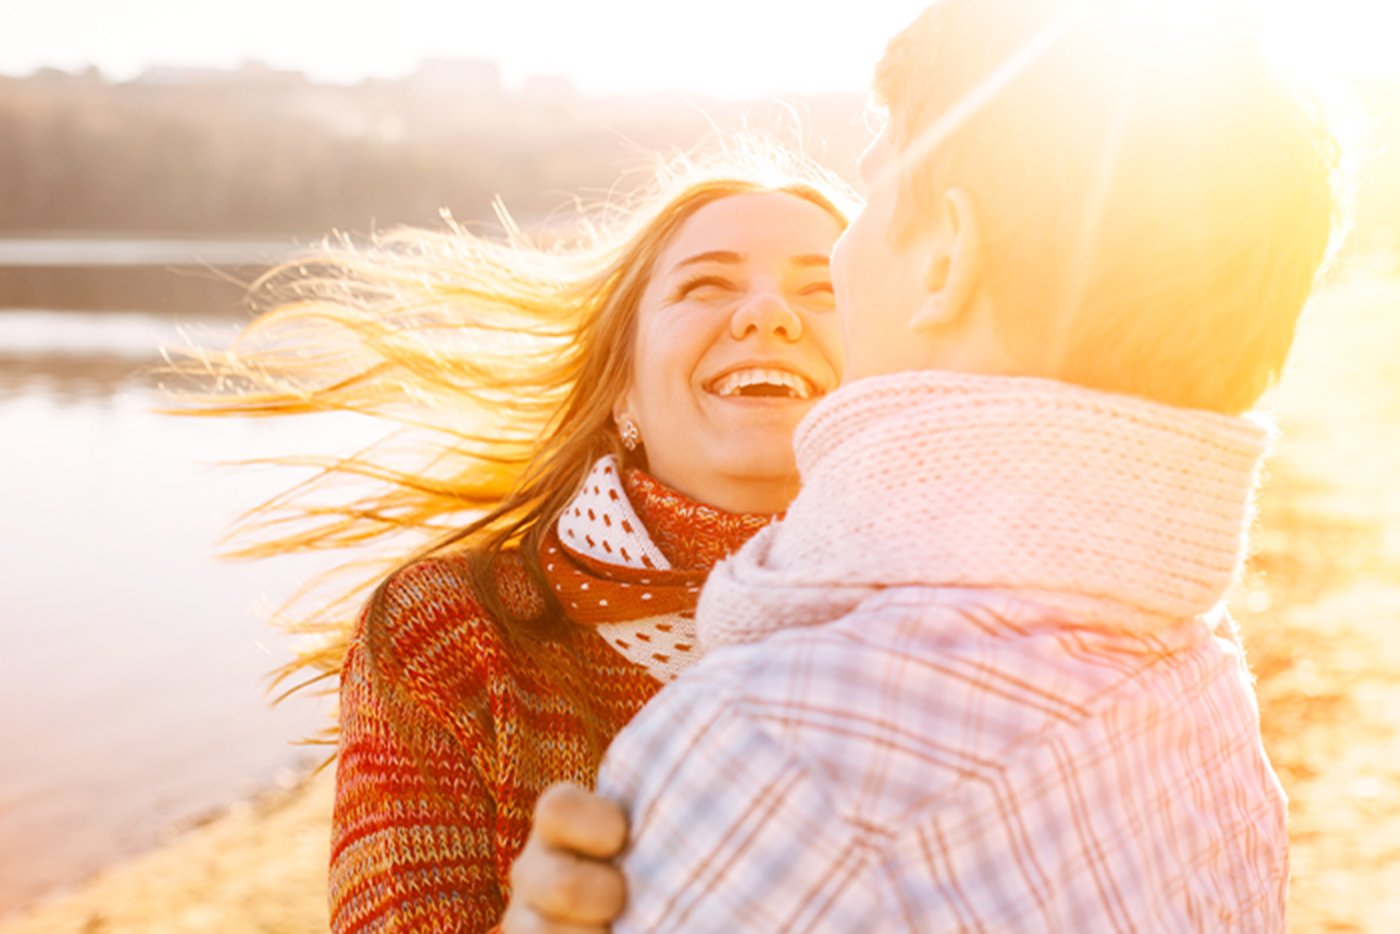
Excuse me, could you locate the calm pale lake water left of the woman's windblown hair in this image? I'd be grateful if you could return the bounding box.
[0,309,378,916]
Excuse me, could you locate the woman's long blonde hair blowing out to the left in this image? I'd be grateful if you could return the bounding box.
[174,139,854,708]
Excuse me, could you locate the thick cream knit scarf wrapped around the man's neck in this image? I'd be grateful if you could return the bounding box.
[699,371,1270,650]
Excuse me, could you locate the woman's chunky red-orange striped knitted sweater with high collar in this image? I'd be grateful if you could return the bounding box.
[330,471,764,933]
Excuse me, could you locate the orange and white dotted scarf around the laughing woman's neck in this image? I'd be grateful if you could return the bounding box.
[540,456,771,683]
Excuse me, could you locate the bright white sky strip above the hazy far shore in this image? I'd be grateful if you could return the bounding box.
[8,0,1400,97]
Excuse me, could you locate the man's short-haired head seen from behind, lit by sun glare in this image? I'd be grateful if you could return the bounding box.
[833,0,1337,412]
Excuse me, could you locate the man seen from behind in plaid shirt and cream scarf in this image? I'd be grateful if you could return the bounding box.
[506,0,1334,931]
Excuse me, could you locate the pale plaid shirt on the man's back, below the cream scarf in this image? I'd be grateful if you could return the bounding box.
[599,587,1288,931]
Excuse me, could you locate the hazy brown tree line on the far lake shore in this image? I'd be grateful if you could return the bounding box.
[0,73,865,235]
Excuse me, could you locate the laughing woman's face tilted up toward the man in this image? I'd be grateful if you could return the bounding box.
[617,192,841,513]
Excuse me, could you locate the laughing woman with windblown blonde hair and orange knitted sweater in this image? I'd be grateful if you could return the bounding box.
[183,142,847,931]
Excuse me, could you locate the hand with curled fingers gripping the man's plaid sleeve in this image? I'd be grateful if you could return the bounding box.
[500,783,627,934]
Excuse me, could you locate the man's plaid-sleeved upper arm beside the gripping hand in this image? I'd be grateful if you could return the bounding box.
[598,663,879,931]
